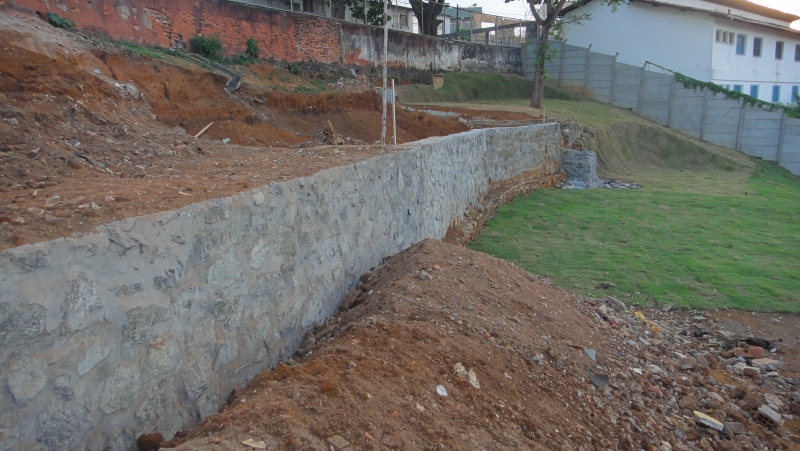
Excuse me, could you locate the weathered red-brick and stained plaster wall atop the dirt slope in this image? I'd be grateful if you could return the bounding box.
[0,0,522,74]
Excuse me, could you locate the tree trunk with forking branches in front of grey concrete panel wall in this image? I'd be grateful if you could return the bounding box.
[505,0,628,108]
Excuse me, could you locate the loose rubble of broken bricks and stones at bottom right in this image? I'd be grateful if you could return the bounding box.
[588,298,800,451]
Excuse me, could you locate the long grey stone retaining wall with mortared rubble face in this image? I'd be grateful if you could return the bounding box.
[0,124,561,451]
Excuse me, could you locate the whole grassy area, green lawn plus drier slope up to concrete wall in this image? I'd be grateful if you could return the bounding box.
[462,88,800,312]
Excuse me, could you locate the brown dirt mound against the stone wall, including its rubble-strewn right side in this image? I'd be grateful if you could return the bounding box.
[155,241,800,450]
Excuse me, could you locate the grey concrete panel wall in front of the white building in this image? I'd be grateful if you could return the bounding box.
[525,41,800,174]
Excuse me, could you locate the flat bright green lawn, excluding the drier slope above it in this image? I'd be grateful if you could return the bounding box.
[472,160,800,313]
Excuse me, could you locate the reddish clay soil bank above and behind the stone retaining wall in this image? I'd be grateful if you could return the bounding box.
[0,13,468,250]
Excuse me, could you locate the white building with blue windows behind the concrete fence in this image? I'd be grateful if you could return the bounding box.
[564,0,800,103]
